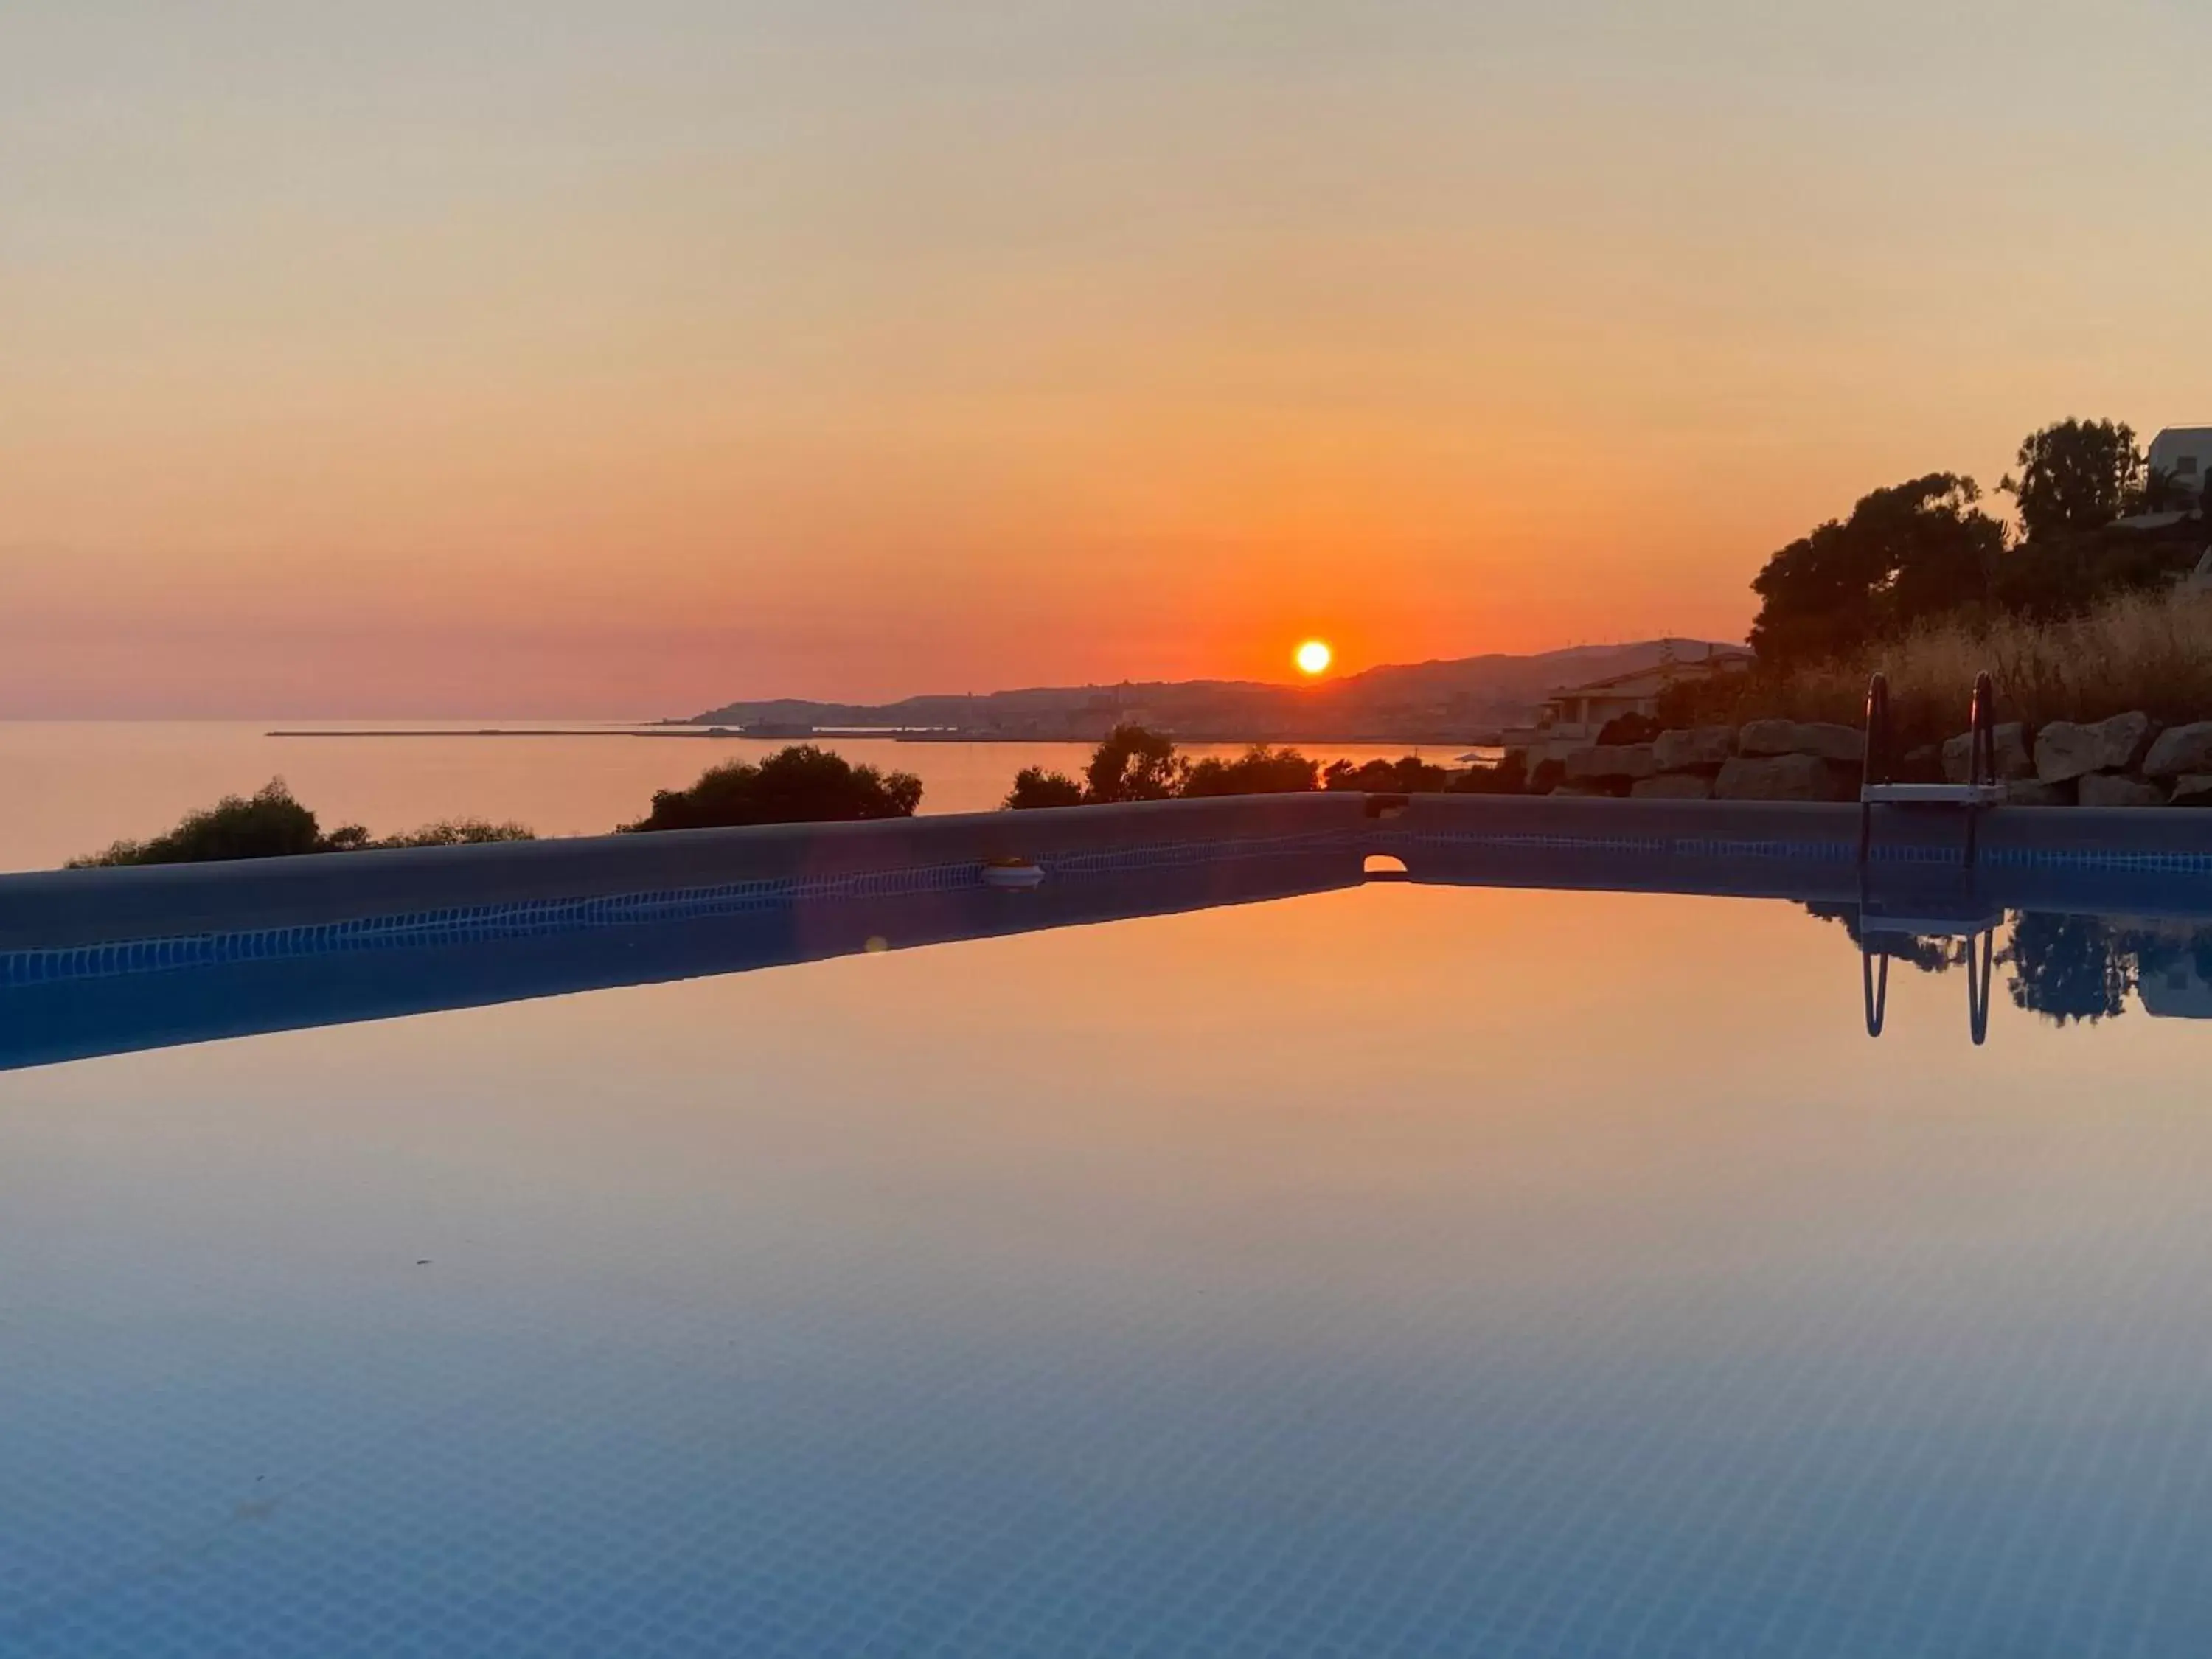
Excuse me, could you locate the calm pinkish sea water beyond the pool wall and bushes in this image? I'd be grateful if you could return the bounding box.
[0,721,1449,885]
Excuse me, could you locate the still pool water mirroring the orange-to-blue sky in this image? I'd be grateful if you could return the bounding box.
[0,887,2212,1655]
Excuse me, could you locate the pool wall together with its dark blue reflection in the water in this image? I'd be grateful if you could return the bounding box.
[13,794,2212,1068]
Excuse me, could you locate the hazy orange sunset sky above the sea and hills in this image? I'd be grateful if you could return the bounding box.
[0,0,2212,717]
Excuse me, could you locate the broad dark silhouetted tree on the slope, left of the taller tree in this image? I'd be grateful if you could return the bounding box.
[1752,473,2004,661]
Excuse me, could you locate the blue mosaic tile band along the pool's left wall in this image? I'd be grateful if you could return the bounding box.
[0,832,1360,987]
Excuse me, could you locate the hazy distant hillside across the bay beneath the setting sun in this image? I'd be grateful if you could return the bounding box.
[688,639,1741,743]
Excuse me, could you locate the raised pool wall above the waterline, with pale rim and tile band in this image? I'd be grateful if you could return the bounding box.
[0,794,2212,969]
